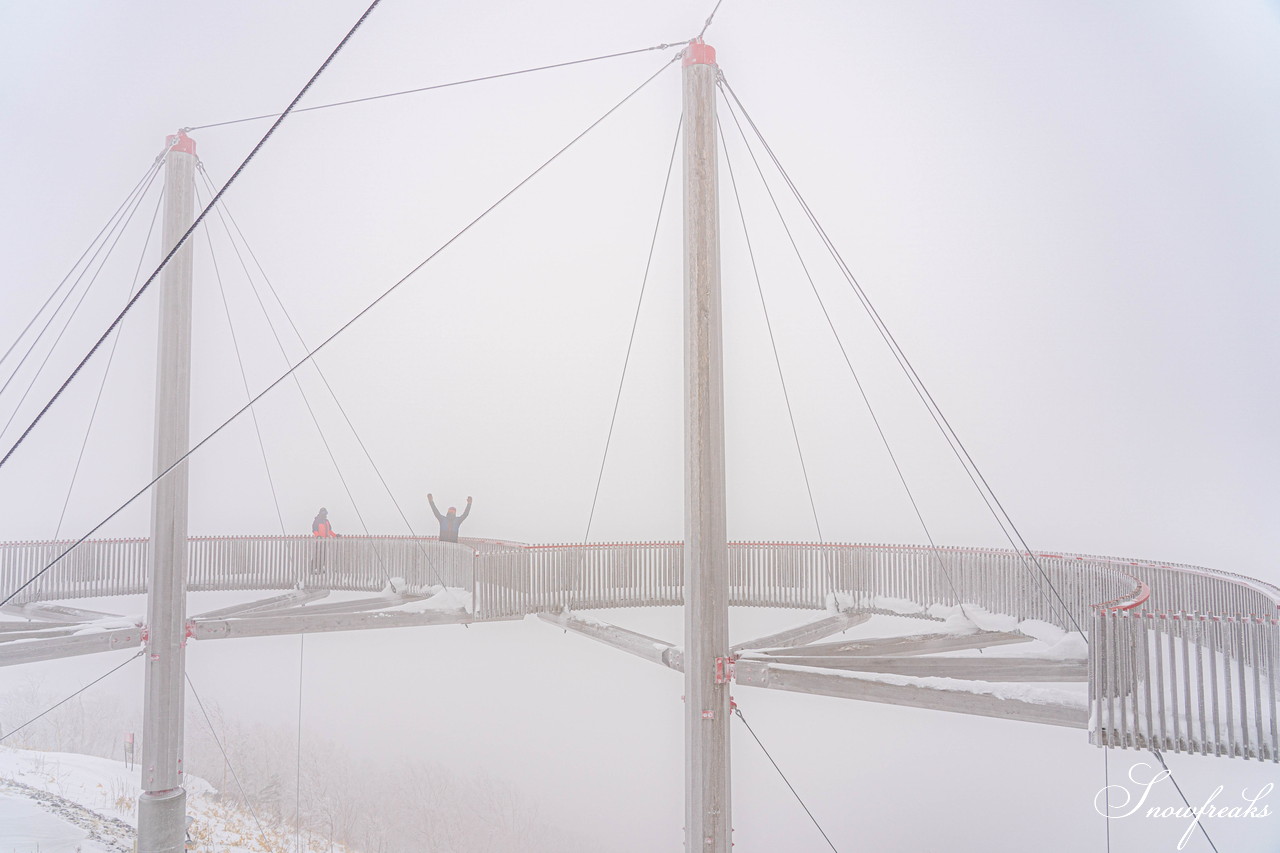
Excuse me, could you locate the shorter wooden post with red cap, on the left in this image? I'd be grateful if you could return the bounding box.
[137,131,196,853]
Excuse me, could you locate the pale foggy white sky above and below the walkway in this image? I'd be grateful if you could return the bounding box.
[0,0,1280,850]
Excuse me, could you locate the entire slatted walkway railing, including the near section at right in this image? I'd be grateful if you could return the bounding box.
[0,537,1280,761]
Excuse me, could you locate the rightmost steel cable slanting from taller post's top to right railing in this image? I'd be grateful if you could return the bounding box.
[721,74,1088,630]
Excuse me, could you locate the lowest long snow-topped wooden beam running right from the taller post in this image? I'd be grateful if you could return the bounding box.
[735,660,1089,729]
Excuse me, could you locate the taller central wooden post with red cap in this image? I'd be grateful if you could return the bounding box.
[684,38,731,853]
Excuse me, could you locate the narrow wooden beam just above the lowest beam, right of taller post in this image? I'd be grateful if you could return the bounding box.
[755,654,1089,681]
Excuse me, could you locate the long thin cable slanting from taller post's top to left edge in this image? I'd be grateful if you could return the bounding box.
[0,54,680,606]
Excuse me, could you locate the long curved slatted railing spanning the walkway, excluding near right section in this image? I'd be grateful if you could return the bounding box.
[0,535,1280,628]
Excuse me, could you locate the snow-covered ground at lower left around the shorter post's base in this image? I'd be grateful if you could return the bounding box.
[0,747,347,853]
